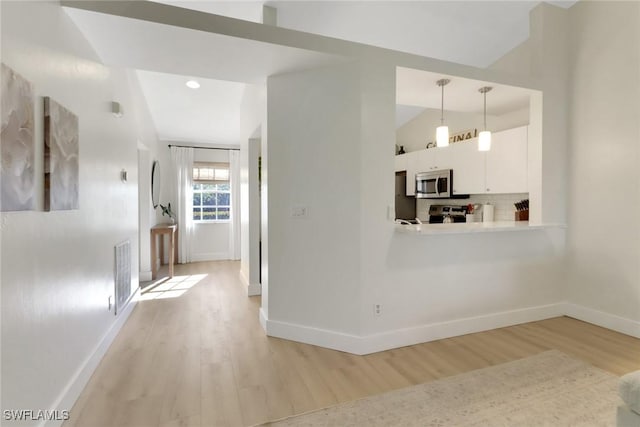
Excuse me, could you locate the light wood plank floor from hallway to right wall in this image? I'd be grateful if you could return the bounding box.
[65,262,640,427]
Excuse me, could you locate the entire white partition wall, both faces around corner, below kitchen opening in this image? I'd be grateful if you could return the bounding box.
[263,62,564,353]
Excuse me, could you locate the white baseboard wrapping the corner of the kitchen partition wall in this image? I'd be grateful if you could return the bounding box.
[260,304,564,355]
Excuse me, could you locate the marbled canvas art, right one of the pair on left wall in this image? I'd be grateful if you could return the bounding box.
[44,97,79,211]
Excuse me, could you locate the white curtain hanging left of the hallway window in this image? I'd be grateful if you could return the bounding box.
[170,147,193,264]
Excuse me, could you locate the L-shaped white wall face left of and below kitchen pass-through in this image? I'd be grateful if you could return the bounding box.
[360,61,562,351]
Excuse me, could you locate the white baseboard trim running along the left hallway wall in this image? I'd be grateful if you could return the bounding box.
[40,287,140,427]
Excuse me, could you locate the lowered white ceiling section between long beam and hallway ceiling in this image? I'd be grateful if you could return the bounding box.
[66,8,343,83]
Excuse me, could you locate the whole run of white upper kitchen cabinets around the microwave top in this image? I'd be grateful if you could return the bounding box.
[396,126,529,196]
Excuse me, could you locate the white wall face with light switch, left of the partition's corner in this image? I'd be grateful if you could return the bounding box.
[262,64,364,333]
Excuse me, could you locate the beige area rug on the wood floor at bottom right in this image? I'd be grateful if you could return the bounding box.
[264,350,621,427]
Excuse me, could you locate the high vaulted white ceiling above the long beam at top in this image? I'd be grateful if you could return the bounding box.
[154,0,577,67]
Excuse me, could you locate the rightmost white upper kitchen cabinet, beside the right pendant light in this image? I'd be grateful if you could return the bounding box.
[484,126,529,193]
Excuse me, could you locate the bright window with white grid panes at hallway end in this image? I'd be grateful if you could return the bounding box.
[193,163,231,221]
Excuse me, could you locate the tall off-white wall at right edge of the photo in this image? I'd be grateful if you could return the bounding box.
[568,1,640,336]
